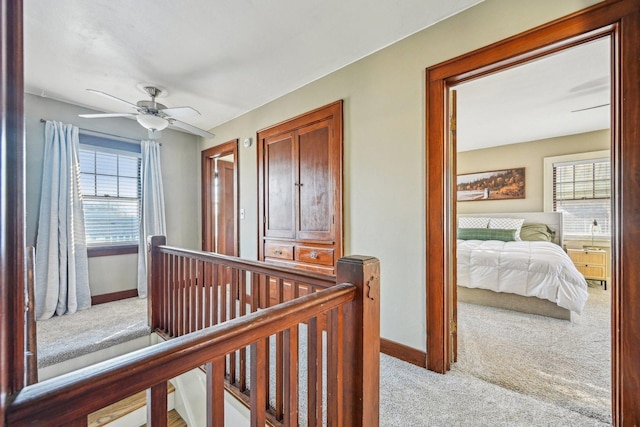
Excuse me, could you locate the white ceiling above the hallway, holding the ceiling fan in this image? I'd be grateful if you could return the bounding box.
[25,0,482,135]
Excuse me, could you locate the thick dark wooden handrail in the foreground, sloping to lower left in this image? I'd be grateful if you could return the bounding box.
[6,284,357,425]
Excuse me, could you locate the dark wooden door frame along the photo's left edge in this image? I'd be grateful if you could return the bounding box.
[0,0,26,414]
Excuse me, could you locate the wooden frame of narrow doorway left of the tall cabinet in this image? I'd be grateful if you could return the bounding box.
[201,139,240,256]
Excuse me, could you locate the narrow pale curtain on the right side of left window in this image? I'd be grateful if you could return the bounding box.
[138,141,167,298]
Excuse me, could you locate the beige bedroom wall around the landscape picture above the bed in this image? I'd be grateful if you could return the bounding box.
[458,130,611,213]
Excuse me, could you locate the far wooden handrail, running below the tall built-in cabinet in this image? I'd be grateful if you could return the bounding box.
[156,245,336,288]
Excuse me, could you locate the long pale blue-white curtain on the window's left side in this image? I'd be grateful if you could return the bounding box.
[35,121,91,320]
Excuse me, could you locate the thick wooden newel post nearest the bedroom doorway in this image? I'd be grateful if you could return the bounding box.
[336,255,380,427]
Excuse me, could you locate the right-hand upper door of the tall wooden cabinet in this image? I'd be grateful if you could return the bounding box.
[296,121,335,240]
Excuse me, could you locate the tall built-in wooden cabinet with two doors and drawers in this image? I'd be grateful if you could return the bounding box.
[257,100,343,275]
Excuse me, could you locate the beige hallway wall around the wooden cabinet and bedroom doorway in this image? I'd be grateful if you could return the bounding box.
[201,0,597,350]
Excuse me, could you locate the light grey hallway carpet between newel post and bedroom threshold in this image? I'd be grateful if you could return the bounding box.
[380,355,608,427]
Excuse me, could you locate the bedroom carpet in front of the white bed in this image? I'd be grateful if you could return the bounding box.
[455,286,611,423]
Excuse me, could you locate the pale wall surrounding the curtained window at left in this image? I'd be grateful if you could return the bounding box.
[25,94,200,295]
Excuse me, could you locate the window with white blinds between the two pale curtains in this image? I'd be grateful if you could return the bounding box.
[80,134,140,256]
